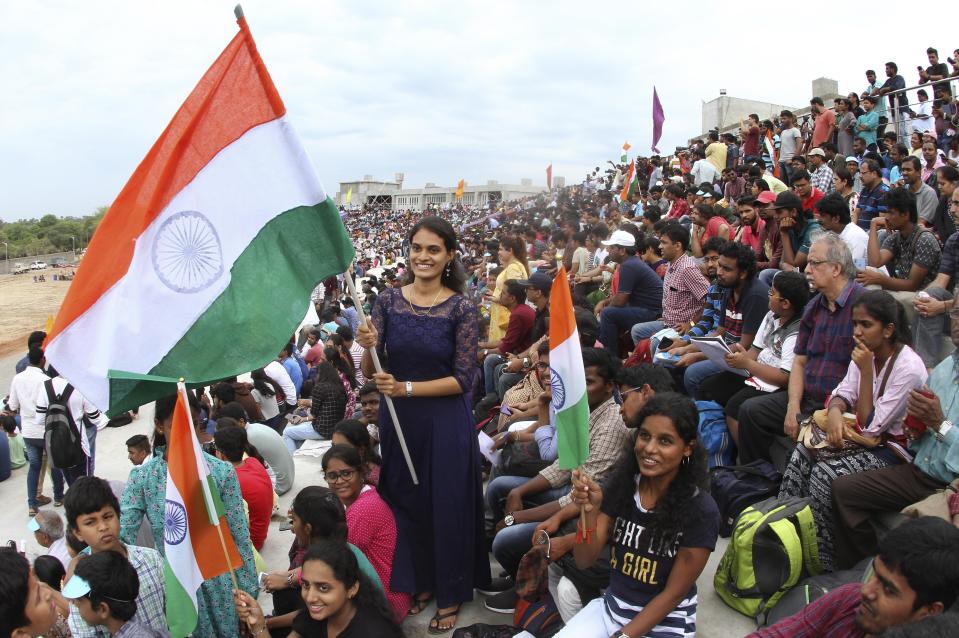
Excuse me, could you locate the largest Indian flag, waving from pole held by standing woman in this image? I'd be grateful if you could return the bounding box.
[47,18,353,414]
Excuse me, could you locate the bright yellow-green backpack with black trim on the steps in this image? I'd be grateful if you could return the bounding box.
[713,498,822,623]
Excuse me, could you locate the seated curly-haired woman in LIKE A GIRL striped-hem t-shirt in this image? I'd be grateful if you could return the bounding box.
[557,392,719,638]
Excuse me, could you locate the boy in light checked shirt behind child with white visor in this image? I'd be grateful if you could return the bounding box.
[63,476,167,638]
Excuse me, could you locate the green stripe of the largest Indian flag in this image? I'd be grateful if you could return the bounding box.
[108,198,354,414]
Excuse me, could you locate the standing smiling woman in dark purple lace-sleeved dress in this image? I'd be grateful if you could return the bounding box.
[357,217,490,634]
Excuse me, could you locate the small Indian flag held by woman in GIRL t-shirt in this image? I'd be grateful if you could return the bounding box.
[549,266,589,470]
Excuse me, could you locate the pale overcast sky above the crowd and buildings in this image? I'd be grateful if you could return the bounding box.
[0,0,959,220]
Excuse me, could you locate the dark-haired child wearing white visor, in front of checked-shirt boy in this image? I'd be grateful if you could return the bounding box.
[62,550,170,638]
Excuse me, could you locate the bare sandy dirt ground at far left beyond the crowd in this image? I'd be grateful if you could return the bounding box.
[0,268,72,355]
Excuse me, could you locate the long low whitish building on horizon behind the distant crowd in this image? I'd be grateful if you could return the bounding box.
[335,173,548,210]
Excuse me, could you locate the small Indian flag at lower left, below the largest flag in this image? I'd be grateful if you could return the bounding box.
[163,382,243,638]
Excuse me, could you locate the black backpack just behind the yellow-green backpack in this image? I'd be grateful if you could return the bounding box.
[709,460,782,538]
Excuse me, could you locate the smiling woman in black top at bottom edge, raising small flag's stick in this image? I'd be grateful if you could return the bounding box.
[233,541,403,638]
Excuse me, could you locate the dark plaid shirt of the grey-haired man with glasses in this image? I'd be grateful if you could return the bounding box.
[795,281,865,403]
